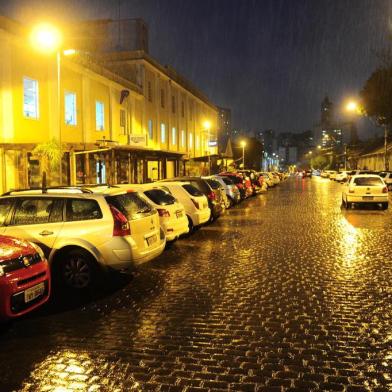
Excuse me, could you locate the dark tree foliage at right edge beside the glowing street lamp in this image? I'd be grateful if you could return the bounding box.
[360,66,392,126]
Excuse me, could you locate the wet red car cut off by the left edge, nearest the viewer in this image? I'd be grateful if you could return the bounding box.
[0,235,50,320]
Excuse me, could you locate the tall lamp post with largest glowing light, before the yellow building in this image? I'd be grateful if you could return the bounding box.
[30,23,63,185]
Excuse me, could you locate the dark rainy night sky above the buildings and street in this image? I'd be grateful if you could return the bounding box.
[0,0,392,136]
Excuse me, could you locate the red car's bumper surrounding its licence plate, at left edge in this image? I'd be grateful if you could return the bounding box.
[0,263,51,320]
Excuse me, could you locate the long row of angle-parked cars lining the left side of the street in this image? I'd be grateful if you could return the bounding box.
[0,170,286,319]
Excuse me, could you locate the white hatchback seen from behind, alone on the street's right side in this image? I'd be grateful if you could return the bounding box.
[342,174,388,210]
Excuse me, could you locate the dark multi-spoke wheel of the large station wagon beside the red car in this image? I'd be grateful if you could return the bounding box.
[57,249,98,291]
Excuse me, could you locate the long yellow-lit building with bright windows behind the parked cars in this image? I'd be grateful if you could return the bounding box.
[0,18,217,192]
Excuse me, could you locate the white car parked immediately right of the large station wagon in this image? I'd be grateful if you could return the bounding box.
[116,183,189,241]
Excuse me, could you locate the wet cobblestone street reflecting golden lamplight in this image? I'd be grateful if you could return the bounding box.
[0,178,392,392]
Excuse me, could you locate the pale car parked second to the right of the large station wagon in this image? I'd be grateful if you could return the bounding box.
[161,181,211,230]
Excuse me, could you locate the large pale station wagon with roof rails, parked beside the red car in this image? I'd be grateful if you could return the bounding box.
[0,187,166,290]
